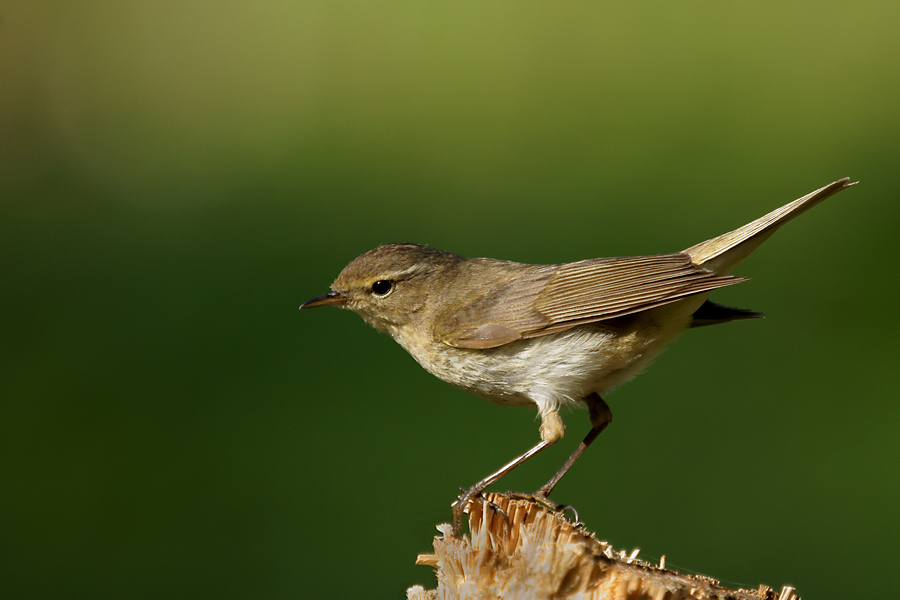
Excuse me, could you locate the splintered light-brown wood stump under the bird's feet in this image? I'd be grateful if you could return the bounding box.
[406,494,800,600]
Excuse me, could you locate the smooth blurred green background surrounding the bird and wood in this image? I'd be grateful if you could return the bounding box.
[0,0,900,599]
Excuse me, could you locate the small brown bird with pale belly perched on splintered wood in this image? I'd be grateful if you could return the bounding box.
[300,178,854,531]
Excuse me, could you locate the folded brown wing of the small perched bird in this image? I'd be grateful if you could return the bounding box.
[434,253,745,348]
